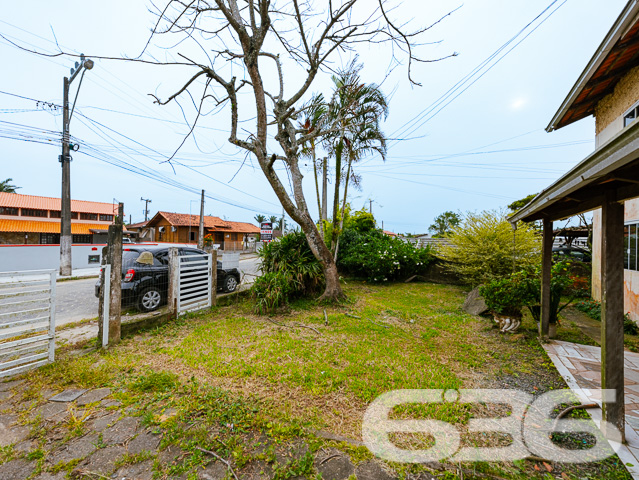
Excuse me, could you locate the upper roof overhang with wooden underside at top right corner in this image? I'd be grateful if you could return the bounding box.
[546,0,639,132]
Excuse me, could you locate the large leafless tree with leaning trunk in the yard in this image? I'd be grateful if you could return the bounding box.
[141,0,454,301]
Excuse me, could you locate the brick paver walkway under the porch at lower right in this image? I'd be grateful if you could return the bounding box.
[544,340,639,479]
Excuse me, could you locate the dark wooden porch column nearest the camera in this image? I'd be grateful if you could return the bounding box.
[601,191,625,442]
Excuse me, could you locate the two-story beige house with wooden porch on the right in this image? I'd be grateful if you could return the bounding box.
[509,0,639,436]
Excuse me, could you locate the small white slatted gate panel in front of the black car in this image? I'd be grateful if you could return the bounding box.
[177,254,212,315]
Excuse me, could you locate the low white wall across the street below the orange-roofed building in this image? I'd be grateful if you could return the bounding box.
[0,244,105,272]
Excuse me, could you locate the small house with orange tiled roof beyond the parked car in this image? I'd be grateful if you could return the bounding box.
[146,212,260,251]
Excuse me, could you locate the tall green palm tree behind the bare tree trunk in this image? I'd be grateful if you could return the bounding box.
[325,60,388,257]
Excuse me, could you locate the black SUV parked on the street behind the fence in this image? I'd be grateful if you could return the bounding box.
[95,245,240,312]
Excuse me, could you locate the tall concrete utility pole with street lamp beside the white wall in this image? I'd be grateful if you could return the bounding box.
[58,54,93,275]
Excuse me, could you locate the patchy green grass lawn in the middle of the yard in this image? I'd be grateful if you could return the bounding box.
[0,281,630,479]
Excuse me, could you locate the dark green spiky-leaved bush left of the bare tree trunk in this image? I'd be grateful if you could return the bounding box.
[251,232,324,314]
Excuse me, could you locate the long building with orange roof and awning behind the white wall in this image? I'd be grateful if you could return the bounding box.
[0,192,118,245]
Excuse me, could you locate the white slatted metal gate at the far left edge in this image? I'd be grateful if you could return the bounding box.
[0,270,56,378]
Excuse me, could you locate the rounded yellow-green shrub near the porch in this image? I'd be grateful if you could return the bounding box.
[439,211,541,286]
